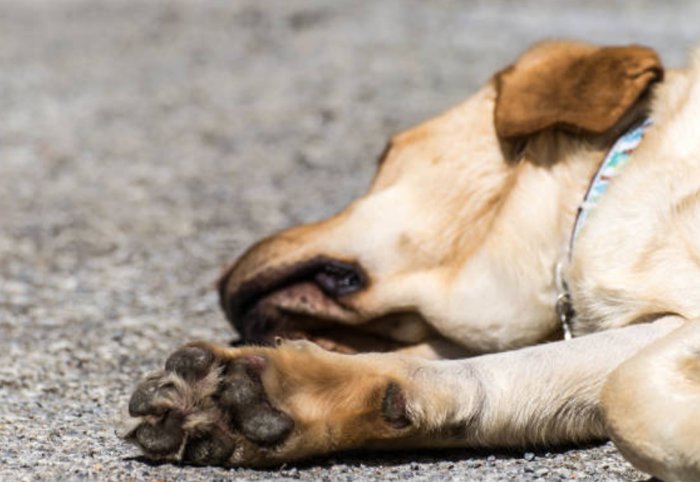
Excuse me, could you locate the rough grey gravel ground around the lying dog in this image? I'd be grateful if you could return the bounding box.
[0,0,700,481]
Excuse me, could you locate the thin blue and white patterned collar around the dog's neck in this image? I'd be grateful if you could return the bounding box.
[555,118,652,340]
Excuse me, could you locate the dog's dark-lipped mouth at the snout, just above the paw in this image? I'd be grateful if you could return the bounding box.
[220,258,432,353]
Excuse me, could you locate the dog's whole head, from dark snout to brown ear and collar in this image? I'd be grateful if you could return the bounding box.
[219,42,662,352]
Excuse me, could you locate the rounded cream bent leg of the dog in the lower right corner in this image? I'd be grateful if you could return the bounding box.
[603,320,700,481]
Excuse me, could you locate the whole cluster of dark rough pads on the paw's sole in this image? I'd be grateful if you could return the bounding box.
[124,345,294,465]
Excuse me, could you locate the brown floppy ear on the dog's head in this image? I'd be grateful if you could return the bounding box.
[495,42,663,139]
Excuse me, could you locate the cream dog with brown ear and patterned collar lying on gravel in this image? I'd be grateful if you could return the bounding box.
[123,41,700,480]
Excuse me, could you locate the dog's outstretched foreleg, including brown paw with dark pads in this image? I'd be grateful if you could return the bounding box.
[125,320,677,465]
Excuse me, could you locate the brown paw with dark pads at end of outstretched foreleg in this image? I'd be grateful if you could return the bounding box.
[124,342,412,466]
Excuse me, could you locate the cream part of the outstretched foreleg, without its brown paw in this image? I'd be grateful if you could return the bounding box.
[410,318,682,447]
